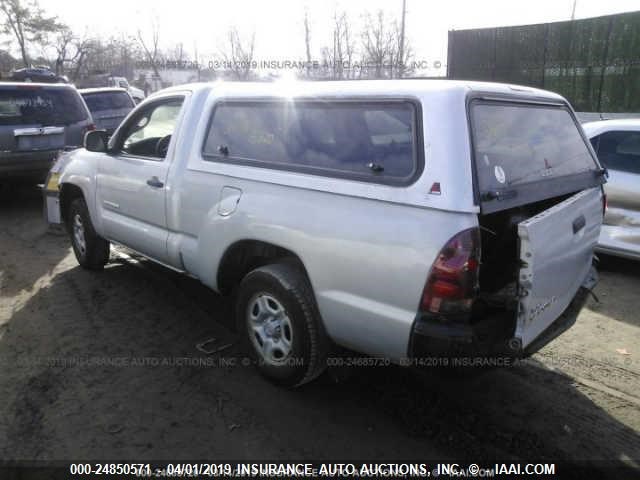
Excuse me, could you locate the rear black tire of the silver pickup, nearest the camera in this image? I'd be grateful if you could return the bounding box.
[236,263,329,387]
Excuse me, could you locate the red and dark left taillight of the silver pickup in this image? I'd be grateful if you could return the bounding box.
[420,228,480,315]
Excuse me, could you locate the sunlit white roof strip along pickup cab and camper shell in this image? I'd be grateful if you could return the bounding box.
[151,79,565,102]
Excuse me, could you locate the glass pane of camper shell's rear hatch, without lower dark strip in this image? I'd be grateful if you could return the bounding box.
[471,102,597,192]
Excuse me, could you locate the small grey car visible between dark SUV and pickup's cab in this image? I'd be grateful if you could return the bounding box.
[80,88,136,134]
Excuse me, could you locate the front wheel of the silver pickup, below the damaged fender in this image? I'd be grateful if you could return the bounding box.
[66,198,110,270]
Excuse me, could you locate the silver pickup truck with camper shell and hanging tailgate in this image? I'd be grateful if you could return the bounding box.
[43,80,604,385]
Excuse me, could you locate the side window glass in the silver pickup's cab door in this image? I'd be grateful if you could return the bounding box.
[121,99,183,160]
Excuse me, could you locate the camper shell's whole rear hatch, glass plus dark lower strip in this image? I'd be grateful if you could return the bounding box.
[470,100,603,211]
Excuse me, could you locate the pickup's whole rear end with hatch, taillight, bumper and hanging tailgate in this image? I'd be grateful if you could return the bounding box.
[410,93,606,365]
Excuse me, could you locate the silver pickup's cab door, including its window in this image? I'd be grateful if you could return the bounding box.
[96,96,184,263]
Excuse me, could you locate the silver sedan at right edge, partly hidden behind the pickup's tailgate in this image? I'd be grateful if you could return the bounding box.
[582,119,640,260]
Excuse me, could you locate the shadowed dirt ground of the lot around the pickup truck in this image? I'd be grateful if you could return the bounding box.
[0,188,640,469]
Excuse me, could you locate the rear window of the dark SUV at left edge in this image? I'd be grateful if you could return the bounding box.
[0,87,88,125]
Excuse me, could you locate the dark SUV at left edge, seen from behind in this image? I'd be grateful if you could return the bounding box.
[0,83,93,181]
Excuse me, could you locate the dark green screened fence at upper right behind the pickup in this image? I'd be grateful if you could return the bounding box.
[447,11,640,112]
